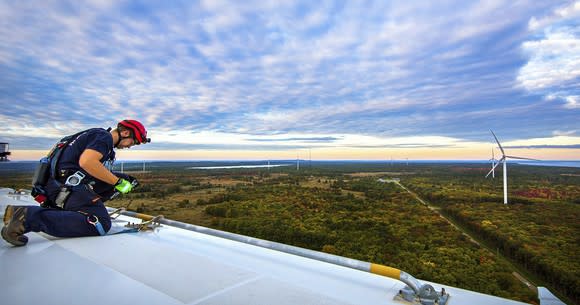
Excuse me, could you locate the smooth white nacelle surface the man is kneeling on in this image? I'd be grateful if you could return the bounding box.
[0,189,525,305]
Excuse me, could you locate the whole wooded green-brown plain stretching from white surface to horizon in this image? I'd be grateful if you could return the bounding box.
[0,162,580,304]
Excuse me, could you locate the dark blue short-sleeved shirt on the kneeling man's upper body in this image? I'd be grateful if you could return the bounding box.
[58,128,115,178]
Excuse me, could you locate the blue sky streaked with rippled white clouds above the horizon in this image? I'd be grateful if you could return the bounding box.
[0,0,580,160]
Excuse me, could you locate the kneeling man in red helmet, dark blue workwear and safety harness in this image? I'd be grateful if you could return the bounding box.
[1,120,151,246]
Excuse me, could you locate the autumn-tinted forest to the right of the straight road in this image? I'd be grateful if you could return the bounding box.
[407,165,580,304]
